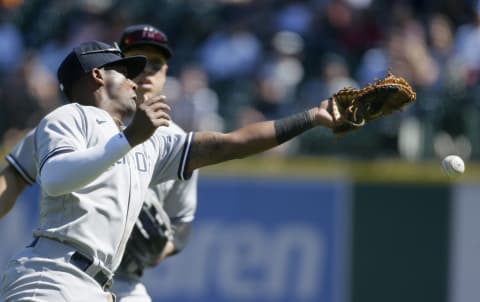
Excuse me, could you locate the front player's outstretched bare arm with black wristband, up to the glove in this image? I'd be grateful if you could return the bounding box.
[185,100,333,175]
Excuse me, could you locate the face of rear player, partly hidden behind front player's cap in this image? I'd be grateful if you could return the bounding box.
[125,46,168,99]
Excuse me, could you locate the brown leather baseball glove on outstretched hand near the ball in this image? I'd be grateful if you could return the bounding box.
[328,71,416,135]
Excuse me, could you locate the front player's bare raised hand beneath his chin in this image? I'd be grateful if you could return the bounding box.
[124,96,170,146]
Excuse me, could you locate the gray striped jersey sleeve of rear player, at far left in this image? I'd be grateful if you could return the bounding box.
[5,129,37,185]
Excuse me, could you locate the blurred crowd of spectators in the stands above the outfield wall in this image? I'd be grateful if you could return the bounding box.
[0,0,480,160]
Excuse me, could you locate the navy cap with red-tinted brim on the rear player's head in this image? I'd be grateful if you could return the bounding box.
[119,24,173,59]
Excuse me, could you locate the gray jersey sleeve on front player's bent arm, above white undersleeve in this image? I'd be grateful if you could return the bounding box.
[35,104,87,175]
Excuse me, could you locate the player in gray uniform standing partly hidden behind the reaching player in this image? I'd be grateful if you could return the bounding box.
[0,24,198,301]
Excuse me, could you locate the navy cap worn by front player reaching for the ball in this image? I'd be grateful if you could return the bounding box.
[57,41,147,98]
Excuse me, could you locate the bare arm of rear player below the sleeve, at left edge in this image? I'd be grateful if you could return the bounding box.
[0,165,27,218]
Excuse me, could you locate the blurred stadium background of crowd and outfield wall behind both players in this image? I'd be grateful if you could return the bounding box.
[0,0,480,302]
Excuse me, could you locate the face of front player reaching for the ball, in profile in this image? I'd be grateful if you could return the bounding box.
[105,66,137,113]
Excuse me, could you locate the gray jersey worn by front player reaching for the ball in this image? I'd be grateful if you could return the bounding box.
[34,104,193,270]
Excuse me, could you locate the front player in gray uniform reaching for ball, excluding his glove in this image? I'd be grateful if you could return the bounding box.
[0,37,334,301]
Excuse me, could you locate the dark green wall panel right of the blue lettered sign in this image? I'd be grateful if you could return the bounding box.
[350,183,451,302]
